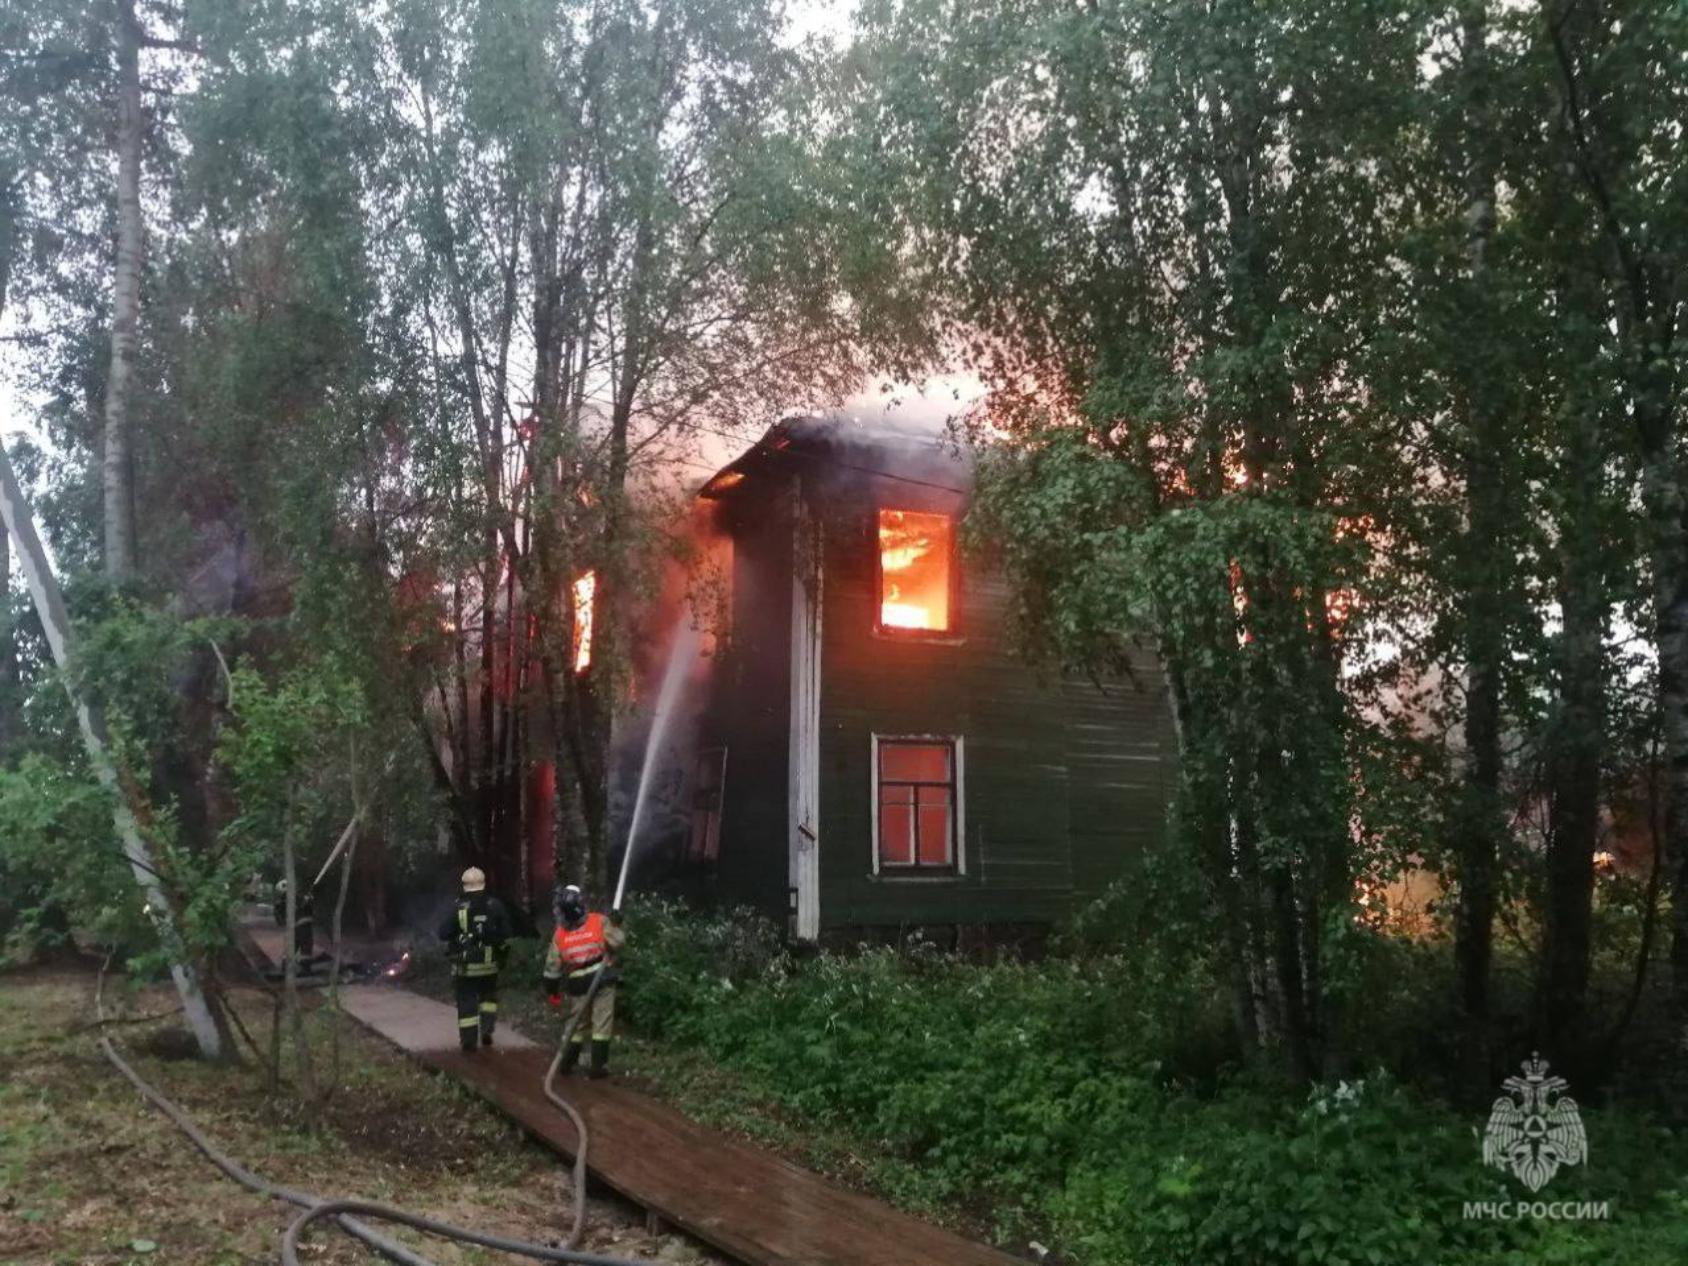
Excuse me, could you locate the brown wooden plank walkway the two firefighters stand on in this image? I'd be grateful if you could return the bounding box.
[246,925,1023,1266]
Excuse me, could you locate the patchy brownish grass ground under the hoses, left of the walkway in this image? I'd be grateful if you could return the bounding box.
[0,964,712,1266]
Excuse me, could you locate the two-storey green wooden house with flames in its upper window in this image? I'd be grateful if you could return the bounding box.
[684,414,1173,940]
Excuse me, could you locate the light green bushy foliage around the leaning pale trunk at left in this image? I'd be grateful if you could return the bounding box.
[0,586,391,977]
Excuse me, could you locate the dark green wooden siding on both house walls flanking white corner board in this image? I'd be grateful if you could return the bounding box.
[704,486,1173,933]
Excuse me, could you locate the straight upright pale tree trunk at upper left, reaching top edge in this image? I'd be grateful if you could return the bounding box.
[101,0,145,584]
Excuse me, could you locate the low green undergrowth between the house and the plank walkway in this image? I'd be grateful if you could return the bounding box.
[625,903,1688,1266]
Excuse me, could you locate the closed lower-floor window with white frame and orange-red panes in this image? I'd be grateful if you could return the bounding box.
[874,738,960,873]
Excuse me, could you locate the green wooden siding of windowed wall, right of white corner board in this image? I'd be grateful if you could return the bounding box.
[820,501,1173,928]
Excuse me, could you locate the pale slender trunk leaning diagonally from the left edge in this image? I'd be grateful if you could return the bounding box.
[0,447,223,1060]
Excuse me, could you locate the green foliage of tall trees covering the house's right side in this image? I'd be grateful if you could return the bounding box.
[850,0,1688,1075]
